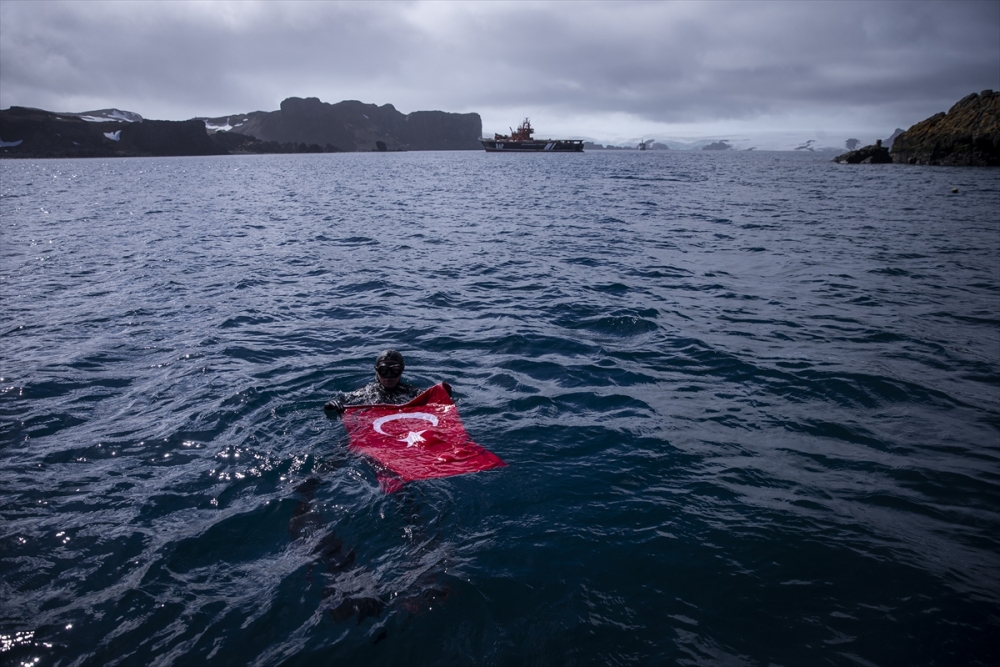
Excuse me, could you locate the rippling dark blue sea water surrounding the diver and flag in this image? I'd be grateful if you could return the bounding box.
[0,152,1000,667]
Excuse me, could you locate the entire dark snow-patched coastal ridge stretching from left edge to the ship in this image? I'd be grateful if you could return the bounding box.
[0,97,482,158]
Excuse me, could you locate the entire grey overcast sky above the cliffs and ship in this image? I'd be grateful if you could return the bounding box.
[0,0,1000,142]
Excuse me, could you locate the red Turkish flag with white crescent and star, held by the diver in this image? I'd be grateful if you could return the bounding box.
[343,383,507,492]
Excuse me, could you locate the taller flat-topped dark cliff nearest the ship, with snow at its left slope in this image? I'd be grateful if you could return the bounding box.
[204,97,483,151]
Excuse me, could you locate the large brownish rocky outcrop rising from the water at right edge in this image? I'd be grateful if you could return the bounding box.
[892,90,1000,167]
